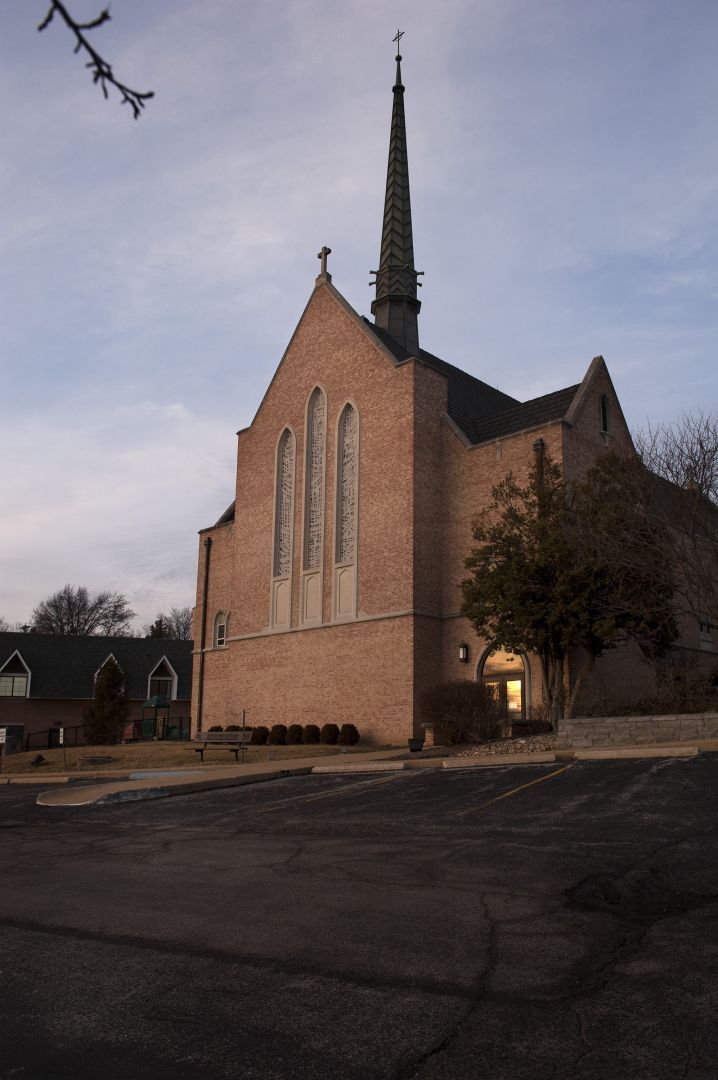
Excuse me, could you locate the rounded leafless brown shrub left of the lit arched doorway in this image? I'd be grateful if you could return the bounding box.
[421,679,506,746]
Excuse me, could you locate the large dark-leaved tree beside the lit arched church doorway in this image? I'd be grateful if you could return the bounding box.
[462,455,677,727]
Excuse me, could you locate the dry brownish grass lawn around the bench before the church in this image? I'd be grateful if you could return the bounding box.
[2,742,380,778]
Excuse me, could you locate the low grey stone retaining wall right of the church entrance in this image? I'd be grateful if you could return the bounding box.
[557,713,718,750]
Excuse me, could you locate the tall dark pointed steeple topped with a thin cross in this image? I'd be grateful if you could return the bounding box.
[371,30,421,356]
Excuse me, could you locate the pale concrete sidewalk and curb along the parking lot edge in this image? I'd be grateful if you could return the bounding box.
[26,740,718,807]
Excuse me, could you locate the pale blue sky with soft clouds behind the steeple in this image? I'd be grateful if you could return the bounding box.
[0,0,718,624]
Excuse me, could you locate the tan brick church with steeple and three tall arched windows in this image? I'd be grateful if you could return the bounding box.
[192,48,635,744]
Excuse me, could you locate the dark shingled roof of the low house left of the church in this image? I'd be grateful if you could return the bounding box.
[0,633,192,711]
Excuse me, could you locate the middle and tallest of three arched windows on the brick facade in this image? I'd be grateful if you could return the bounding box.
[301,387,326,622]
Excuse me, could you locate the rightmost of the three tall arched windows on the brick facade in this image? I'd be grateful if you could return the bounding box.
[334,403,358,619]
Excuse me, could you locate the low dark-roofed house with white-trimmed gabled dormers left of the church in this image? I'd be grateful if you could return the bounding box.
[0,633,192,748]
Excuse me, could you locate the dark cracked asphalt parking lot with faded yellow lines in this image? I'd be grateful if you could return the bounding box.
[0,756,718,1080]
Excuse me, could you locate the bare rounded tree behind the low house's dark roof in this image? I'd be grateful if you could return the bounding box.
[32,585,135,637]
